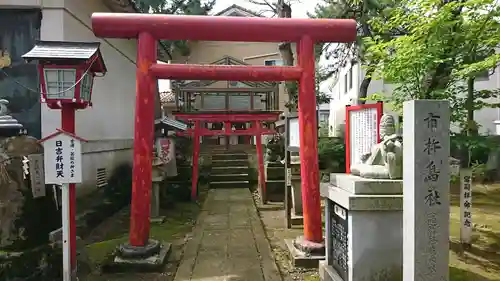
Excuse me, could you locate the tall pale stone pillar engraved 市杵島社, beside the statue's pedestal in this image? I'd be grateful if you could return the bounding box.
[403,100,450,281]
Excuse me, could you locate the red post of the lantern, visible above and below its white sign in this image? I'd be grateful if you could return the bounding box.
[61,104,76,271]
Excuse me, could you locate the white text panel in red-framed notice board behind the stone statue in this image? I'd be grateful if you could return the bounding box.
[349,108,379,165]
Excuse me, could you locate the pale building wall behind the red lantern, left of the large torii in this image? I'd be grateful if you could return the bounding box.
[36,0,136,194]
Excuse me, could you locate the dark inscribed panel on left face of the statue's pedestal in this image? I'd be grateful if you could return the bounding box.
[330,203,349,280]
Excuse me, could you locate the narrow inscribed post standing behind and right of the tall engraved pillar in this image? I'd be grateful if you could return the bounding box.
[460,169,472,245]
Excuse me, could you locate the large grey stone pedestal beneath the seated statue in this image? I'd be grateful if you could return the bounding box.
[319,174,403,281]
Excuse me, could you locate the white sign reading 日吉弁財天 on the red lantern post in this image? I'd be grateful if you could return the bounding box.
[43,132,82,184]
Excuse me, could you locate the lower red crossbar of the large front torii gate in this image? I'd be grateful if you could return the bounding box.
[150,64,302,81]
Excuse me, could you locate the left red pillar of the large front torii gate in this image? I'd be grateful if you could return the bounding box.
[129,32,157,246]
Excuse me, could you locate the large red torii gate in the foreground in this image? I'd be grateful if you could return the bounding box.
[92,13,356,248]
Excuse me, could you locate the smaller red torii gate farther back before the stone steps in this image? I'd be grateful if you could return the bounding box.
[174,111,280,199]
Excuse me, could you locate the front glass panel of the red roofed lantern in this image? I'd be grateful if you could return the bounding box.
[45,68,76,99]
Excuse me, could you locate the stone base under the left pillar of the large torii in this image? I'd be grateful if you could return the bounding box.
[103,243,172,272]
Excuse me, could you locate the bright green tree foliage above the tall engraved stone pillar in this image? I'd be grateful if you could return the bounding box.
[364,0,500,130]
